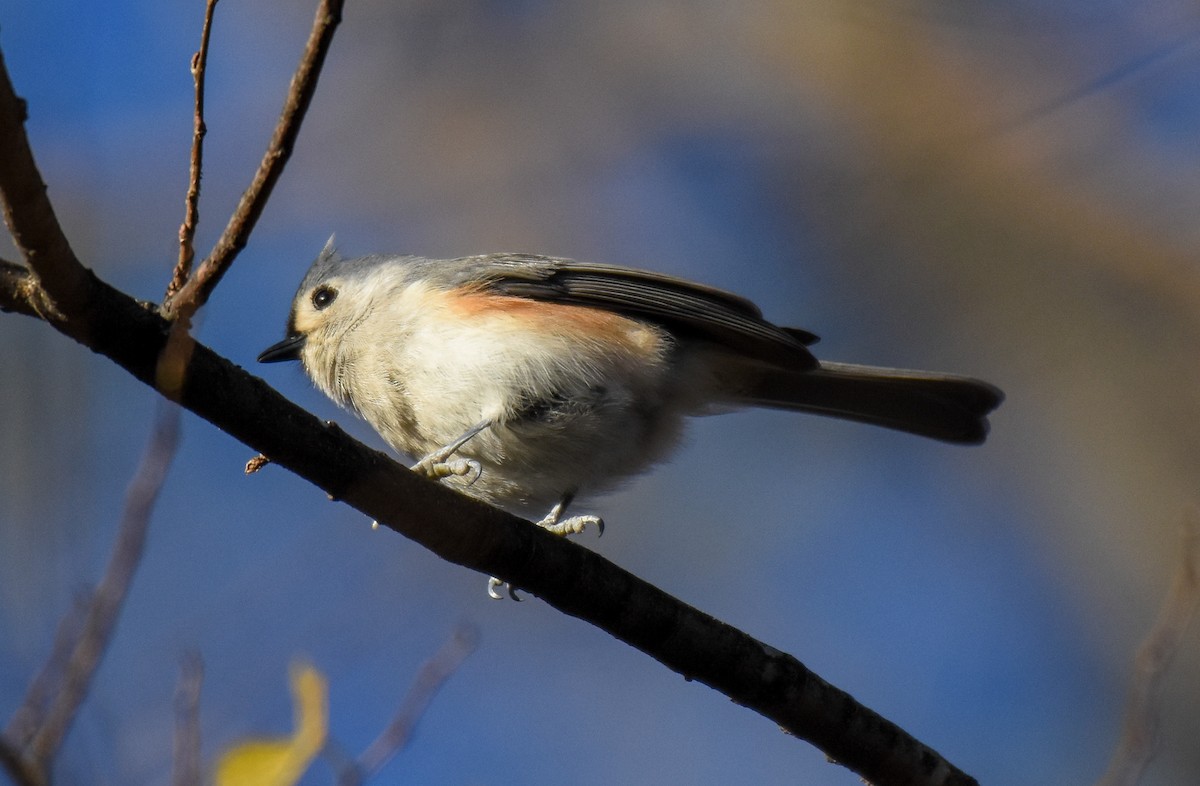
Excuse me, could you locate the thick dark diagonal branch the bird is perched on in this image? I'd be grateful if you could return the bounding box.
[0,266,976,786]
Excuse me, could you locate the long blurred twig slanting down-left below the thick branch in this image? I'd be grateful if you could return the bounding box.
[29,403,180,770]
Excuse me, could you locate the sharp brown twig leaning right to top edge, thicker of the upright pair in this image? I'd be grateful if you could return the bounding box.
[163,0,344,318]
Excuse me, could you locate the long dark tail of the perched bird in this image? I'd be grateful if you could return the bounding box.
[733,362,1004,444]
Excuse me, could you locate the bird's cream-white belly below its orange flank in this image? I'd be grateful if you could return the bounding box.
[358,306,682,516]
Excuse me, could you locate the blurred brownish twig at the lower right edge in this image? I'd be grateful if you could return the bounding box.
[1097,509,1200,786]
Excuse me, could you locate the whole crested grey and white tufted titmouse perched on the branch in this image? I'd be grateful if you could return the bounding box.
[258,239,1003,592]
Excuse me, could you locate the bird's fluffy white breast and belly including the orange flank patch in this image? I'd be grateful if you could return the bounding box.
[347,283,680,515]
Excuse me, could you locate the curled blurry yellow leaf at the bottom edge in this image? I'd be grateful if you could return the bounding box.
[215,664,329,786]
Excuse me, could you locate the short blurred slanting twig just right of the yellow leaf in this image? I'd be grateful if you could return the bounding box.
[337,624,479,786]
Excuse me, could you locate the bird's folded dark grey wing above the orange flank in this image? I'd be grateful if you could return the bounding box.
[456,253,817,370]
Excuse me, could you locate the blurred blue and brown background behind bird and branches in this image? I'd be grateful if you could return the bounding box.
[0,0,1200,785]
